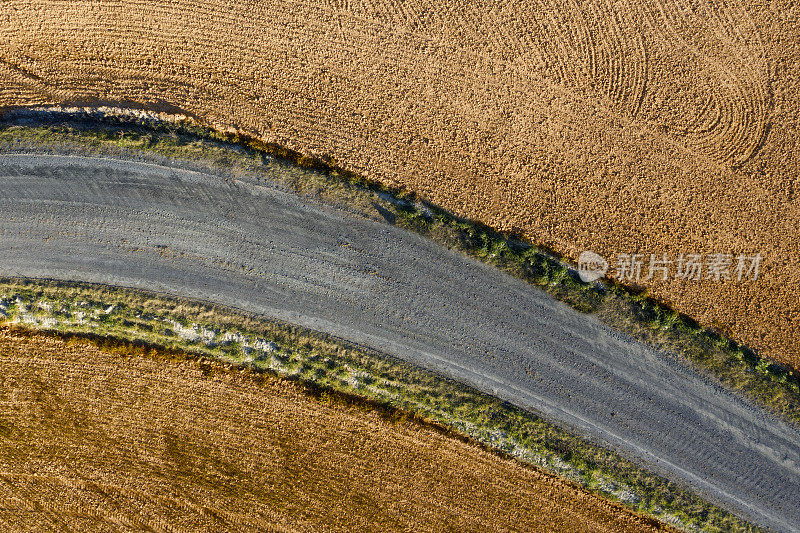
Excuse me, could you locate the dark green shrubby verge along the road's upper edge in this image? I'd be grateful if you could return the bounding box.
[0,108,800,428]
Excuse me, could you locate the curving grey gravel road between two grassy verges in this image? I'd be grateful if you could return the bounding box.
[0,155,800,531]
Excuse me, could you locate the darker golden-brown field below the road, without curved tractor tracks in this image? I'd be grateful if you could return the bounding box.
[0,327,664,531]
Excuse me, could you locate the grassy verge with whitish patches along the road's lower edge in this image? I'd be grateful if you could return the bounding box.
[0,279,756,531]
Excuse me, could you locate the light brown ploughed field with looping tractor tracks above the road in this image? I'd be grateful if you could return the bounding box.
[0,0,800,365]
